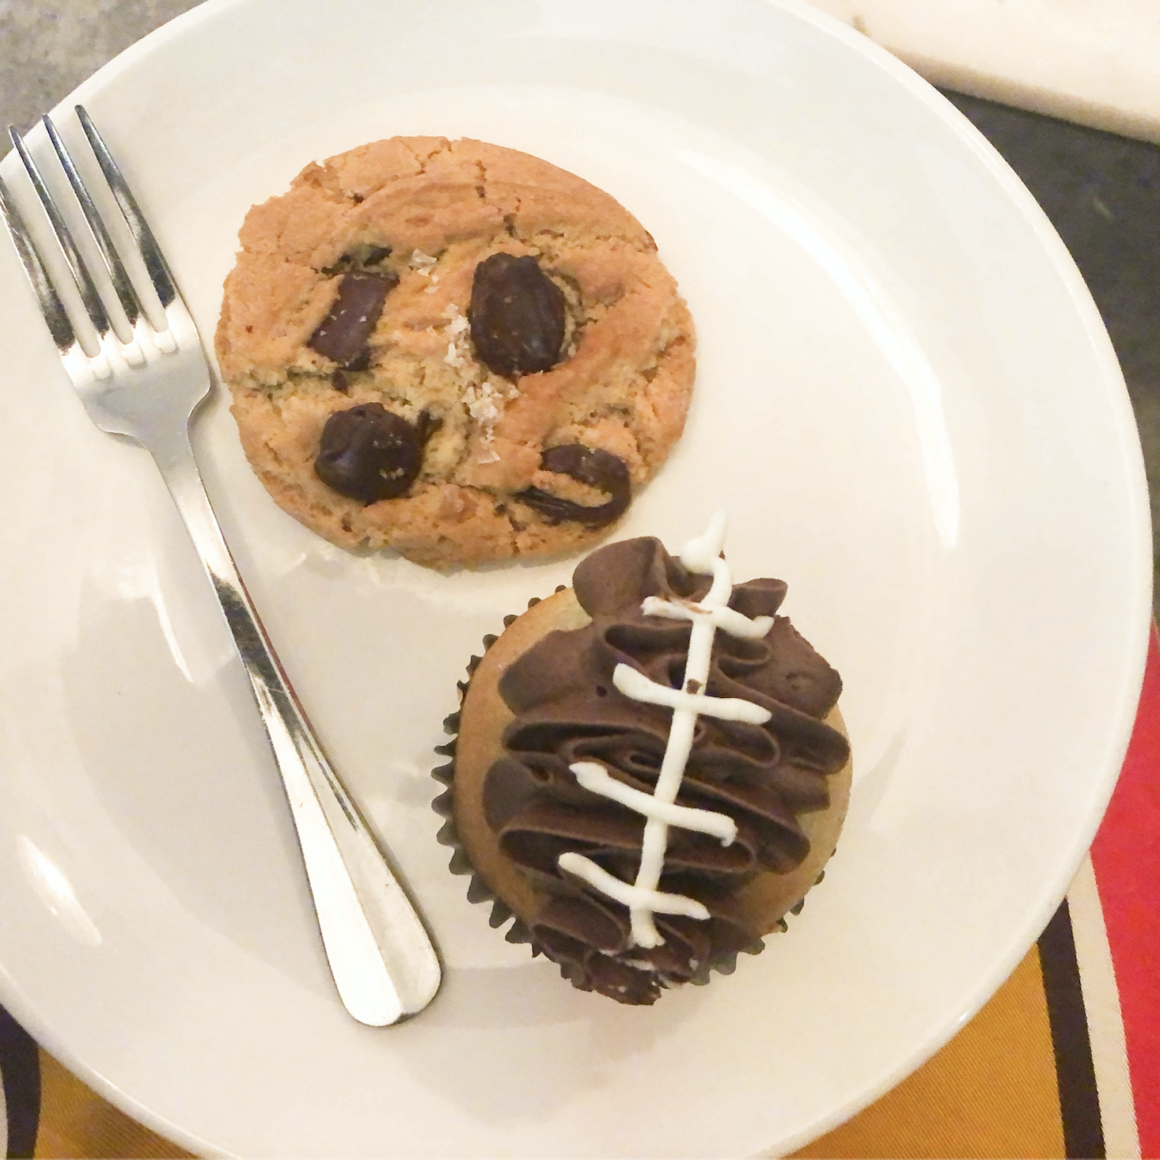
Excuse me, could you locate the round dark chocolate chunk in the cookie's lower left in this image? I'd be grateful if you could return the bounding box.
[314,403,423,503]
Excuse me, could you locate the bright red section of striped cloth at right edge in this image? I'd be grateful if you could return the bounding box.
[1092,625,1160,1157]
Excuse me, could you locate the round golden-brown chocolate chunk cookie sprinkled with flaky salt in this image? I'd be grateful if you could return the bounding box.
[216,137,695,568]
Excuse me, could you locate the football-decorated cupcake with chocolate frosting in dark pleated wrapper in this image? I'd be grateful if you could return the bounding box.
[435,515,850,1003]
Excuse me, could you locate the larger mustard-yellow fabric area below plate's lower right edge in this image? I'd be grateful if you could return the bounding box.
[795,948,1064,1160]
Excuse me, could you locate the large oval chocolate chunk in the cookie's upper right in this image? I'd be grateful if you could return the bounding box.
[467,254,564,378]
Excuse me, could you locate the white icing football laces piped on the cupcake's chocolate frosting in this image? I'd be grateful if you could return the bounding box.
[558,512,774,949]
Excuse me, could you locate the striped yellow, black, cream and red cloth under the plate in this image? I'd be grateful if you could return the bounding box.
[0,632,1160,1158]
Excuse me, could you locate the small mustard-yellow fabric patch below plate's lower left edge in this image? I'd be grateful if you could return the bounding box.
[35,1050,189,1160]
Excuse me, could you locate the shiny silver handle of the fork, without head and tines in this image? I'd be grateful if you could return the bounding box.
[150,430,442,1027]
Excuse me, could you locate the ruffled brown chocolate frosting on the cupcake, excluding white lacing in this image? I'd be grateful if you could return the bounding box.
[484,538,849,1003]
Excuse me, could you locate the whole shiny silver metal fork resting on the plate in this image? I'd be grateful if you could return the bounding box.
[0,106,441,1027]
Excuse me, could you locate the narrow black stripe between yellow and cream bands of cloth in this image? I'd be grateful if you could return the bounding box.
[1039,898,1107,1160]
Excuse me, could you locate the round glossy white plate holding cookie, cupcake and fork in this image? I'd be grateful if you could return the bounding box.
[0,0,1150,1157]
